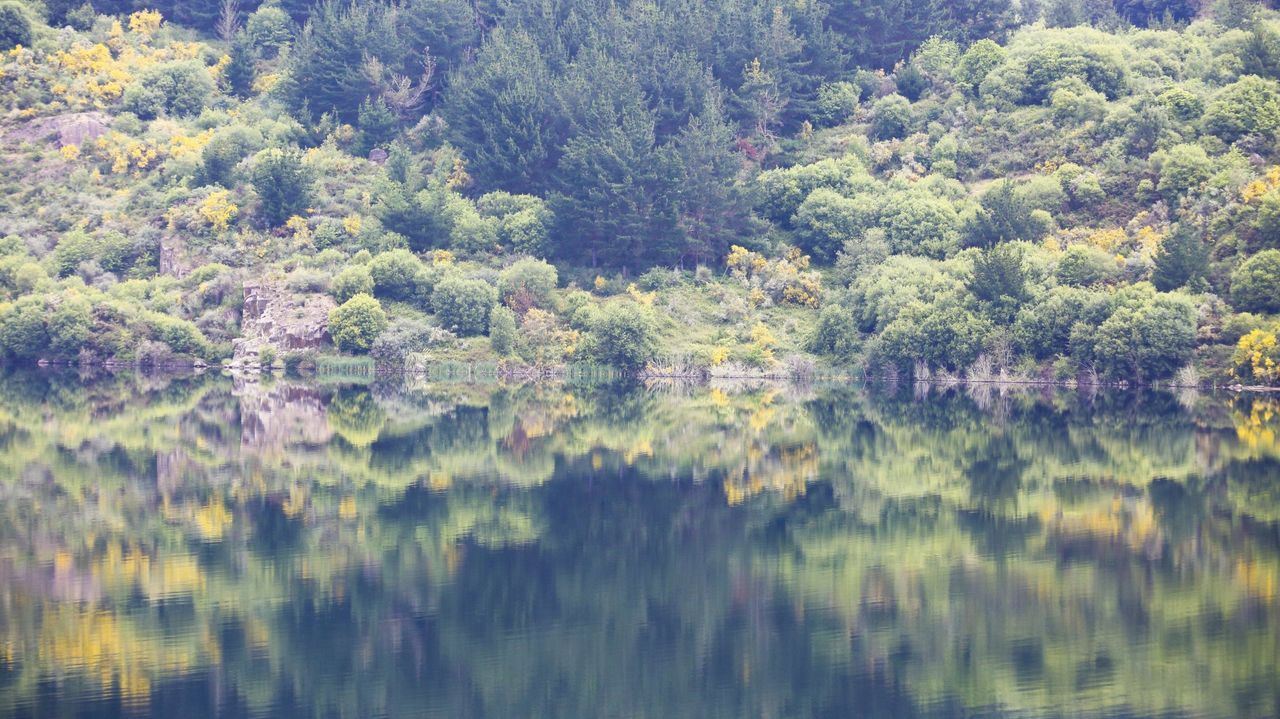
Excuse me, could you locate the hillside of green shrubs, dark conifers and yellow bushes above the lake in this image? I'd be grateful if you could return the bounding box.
[0,0,1280,384]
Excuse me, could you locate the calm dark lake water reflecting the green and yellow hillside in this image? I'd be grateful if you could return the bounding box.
[0,374,1280,719]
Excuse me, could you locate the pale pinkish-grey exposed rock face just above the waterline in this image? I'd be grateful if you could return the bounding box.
[233,281,337,366]
